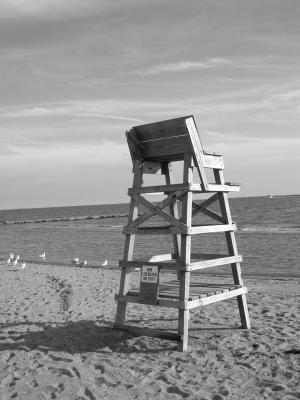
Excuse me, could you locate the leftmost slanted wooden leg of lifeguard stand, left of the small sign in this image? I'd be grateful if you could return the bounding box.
[115,160,143,327]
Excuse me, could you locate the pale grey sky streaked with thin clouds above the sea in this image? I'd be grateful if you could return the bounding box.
[0,0,300,209]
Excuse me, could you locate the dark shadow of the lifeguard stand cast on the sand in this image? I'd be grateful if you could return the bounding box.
[0,320,176,354]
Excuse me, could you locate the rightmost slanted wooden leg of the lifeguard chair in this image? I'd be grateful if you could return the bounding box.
[214,169,251,329]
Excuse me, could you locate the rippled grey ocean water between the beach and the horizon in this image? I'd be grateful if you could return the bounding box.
[0,195,300,277]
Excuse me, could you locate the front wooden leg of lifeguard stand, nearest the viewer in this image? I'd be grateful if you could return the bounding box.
[178,154,193,351]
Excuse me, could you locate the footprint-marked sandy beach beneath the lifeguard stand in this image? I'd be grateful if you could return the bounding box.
[0,263,300,400]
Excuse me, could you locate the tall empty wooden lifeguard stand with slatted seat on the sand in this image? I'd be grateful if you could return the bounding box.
[115,116,250,351]
